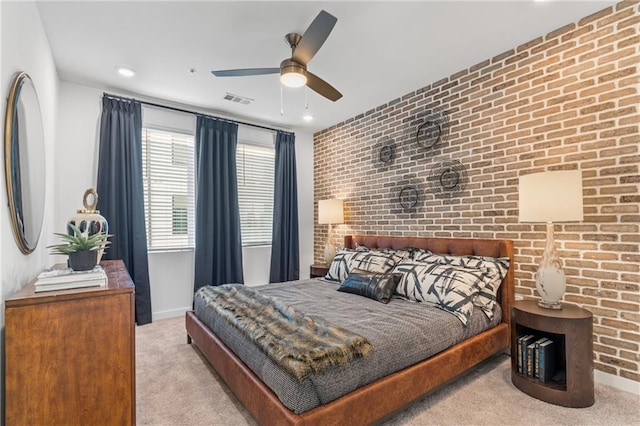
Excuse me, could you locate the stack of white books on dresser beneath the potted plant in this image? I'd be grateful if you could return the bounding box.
[35,263,107,293]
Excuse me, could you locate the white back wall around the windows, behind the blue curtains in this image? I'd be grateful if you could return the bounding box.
[55,82,313,320]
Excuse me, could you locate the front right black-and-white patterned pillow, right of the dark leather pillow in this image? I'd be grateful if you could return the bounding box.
[393,261,483,326]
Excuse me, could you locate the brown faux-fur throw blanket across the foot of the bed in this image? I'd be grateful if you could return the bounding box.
[198,284,372,382]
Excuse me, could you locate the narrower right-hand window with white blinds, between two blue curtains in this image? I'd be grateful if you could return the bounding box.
[236,142,275,246]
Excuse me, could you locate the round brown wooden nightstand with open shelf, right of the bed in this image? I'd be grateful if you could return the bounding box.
[511,300,595,408]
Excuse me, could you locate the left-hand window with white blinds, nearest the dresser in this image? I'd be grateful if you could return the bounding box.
[142,128,195,251]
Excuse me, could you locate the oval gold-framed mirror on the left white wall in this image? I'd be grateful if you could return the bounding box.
[4,72,45,254]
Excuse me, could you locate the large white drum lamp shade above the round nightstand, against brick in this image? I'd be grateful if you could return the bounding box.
[518,170,583,222]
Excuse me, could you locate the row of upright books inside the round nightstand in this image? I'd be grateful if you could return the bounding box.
[516,334,556,382]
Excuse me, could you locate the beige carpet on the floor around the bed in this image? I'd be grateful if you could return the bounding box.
[136,318,640,426]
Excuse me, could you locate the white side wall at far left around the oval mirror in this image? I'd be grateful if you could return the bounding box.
[0,1,58,412]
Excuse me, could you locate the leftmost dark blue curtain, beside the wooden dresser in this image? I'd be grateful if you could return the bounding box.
[97,96,151,325]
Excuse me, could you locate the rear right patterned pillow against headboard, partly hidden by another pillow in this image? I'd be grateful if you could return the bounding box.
[414,250,509,320]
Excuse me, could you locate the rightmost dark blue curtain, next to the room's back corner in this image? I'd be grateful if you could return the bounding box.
[269,131,300,283]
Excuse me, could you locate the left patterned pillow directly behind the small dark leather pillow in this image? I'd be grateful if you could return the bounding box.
[325,249,397,282]
